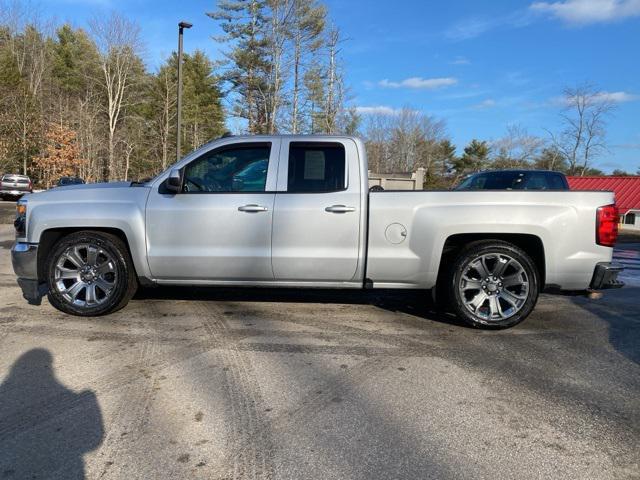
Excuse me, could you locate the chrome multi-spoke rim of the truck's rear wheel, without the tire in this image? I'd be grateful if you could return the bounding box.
[458,253,530,322]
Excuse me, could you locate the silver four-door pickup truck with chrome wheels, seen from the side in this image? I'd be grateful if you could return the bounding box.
[12,136,622,327]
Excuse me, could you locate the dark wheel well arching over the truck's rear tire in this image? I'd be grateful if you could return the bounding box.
[438,233,546,289]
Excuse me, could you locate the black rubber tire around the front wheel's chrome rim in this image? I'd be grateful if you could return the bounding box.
[45,231,138,317]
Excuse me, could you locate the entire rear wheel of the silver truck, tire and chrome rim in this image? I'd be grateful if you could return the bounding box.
[447,240,540,329]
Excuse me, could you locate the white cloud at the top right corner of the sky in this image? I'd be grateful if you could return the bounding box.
[529,0,640,25]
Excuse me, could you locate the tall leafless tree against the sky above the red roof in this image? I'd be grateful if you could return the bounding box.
[550,84,615,175]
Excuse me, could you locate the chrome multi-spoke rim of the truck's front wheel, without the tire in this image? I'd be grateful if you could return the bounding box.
[54,243,118,308]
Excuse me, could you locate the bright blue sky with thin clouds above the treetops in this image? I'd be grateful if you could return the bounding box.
[41,0,640,172]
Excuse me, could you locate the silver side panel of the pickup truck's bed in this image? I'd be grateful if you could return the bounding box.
[366,191,614,290]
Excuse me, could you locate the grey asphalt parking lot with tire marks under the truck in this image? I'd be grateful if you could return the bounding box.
[0,202,640,480]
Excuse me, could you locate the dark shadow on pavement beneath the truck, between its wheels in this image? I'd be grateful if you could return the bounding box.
[134,286,472,328]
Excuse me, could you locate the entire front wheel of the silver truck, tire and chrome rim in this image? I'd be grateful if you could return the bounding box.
[46,231,138,317]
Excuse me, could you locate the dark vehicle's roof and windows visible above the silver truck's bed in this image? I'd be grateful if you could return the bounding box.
[454,170,569,190]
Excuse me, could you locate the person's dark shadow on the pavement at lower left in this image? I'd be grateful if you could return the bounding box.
[0,348,104,480]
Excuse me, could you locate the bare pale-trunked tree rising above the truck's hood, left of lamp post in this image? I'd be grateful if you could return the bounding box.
[90,13,142,180]
